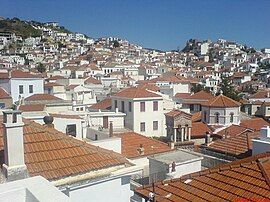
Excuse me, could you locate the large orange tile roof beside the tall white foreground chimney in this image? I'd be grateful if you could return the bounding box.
[0,120,127,180]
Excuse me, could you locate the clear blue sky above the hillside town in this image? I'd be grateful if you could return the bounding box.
[0,0,270,50]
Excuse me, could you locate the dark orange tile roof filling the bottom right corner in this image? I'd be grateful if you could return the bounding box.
[135,153,270,202]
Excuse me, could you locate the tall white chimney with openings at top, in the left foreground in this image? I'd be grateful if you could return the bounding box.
[3,110,28,181]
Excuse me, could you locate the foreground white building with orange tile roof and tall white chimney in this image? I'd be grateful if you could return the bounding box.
[0,111,138,202]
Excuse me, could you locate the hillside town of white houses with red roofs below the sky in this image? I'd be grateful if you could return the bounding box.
[0,18,270,202]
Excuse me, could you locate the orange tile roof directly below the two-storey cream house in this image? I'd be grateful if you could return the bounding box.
[114,132,171,158]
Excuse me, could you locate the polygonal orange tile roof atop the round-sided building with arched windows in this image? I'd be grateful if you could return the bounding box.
[202,95,241,107]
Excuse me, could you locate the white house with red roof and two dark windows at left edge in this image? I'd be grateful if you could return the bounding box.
[0,70,44,102]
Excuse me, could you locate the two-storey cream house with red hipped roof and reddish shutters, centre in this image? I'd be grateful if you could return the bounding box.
[111,87,165,136]
